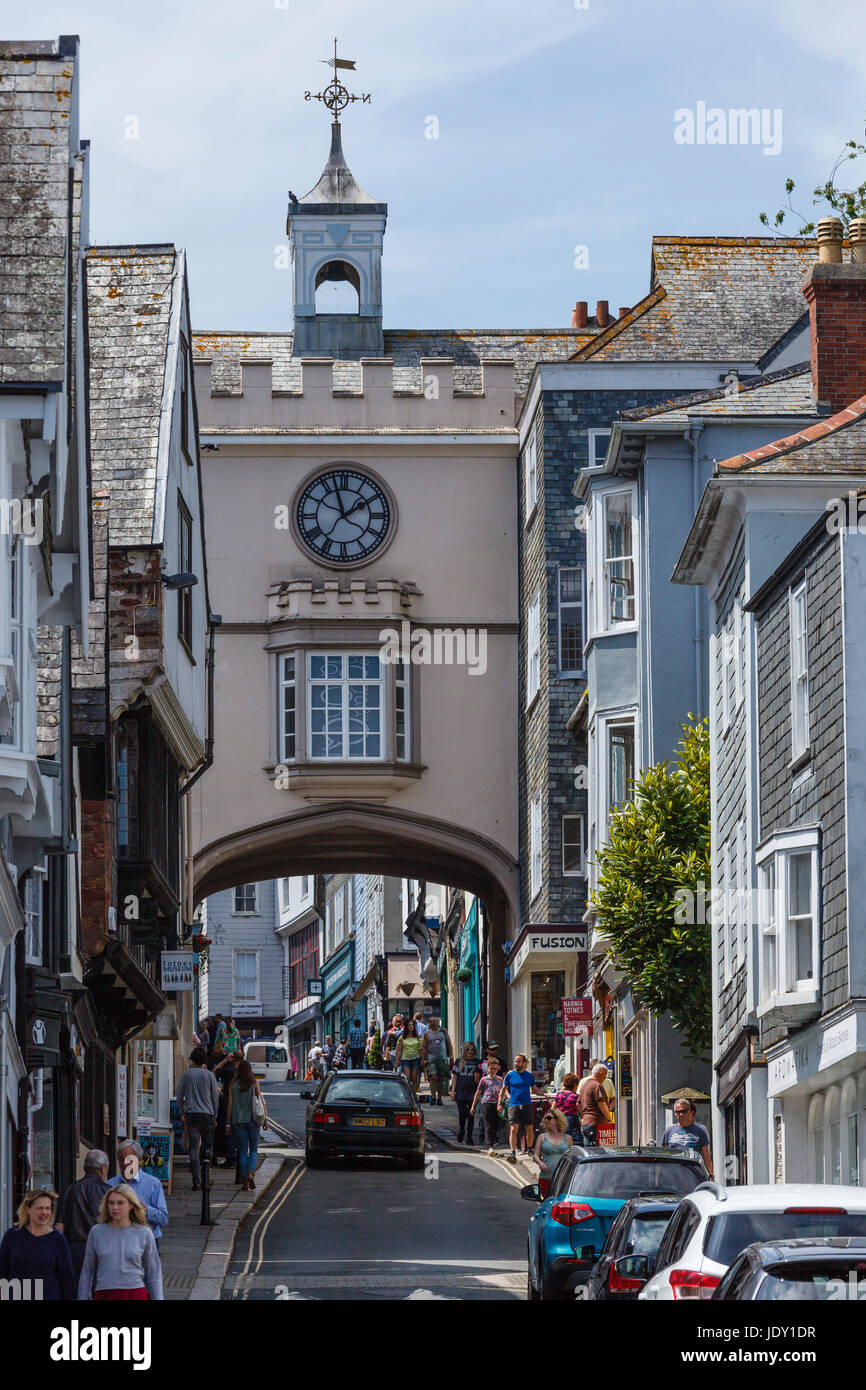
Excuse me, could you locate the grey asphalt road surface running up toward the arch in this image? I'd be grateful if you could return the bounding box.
[222,1083,531,1300]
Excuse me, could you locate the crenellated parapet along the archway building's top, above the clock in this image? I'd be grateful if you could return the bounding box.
[196,357,514,434]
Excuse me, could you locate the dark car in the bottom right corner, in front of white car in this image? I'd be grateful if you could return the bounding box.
[713,1236,866,1302]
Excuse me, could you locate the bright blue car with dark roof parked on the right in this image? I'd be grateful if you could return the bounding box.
[521,1144,706,1300]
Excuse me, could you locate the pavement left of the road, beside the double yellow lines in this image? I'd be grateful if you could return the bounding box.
[160,1150,285,1301]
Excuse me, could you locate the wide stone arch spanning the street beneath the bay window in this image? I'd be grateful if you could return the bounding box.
[193,801,517,1036]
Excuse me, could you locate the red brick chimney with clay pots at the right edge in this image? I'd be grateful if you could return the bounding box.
[803,217,866,413]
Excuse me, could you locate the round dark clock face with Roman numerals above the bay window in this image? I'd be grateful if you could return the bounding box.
[295,466,392,564]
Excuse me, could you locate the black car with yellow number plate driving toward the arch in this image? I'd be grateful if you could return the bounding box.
[300,1072,427,1168]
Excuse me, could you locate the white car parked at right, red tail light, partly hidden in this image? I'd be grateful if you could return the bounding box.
[635,1183,866,1301]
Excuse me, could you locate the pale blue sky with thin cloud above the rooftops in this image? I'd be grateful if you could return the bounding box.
[18,0,866,329]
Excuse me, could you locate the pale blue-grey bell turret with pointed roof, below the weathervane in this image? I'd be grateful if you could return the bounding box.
[286,121,388,360]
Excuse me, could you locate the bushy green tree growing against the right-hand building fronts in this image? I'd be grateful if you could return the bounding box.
[591,714,712,1058]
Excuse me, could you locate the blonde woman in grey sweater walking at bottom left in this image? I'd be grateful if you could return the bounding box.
[78,1183,163,1301]
